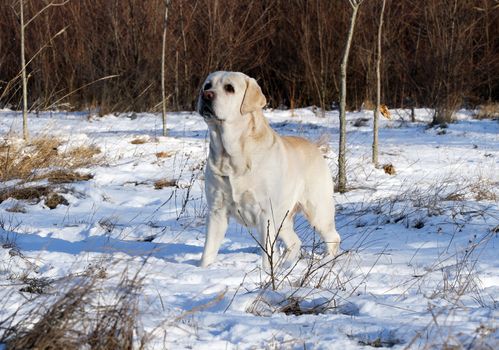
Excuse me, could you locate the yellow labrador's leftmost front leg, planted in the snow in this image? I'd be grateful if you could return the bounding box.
[200,209,229,267]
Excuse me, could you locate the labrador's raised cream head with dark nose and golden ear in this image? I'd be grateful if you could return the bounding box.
[197,72,267,122]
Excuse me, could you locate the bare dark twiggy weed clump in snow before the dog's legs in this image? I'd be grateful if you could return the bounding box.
[246,217,376,316]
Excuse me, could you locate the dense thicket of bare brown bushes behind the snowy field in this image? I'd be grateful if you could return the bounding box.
[0,0,499,115]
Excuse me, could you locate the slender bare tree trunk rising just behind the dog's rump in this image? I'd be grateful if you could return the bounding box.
[338,1,360,193]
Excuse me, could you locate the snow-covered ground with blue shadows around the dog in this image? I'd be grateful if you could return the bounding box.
[0,109,499,349]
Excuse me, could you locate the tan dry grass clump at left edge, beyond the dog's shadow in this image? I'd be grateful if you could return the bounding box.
[0,136,101,182]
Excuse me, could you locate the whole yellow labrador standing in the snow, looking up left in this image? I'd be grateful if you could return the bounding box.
[197,72,340,267]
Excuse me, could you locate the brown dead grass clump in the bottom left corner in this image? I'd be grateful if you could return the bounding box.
[0,273,144,349]
